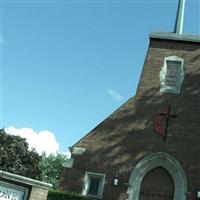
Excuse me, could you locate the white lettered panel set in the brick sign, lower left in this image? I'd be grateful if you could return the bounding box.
[0,185,25,200]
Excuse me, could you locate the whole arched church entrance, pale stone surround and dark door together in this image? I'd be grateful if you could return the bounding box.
[127,152,187,200]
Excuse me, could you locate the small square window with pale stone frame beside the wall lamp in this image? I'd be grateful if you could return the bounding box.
[82,172,105,199]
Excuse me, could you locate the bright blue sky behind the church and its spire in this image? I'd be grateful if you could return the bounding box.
[0,0,200,152]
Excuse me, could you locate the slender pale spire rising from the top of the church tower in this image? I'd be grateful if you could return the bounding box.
[174,0,185,34]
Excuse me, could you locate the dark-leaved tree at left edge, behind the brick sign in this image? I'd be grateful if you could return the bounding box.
[0,129,42,180]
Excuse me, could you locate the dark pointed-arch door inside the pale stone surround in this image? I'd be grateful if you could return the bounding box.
[139,167,174,200]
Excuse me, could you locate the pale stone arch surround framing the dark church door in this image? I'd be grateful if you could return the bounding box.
[127,152,187,200]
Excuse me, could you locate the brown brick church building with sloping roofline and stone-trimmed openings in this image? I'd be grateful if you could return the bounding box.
[60,0,200,200]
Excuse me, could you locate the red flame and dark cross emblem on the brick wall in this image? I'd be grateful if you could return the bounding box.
[155,105,177,139]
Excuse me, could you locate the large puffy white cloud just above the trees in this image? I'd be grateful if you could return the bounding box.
[5,126,59,155]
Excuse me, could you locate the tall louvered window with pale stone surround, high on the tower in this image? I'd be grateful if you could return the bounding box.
[160,56,184,93]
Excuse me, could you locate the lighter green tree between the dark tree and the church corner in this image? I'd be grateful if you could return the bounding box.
[40,153,67,189]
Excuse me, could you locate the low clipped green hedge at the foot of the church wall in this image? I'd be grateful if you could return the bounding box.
[47,190,93,200]
